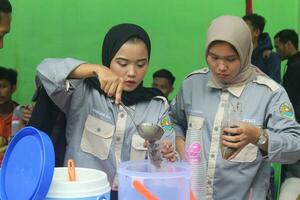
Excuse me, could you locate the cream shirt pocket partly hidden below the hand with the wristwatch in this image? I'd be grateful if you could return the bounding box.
[230,143,258,162]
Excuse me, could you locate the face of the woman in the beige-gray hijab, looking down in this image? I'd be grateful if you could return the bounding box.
[206,42,241,83]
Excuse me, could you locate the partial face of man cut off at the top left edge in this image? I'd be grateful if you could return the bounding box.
[0,0,12,49]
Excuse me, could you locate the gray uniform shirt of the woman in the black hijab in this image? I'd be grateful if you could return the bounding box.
[37,58,175,188]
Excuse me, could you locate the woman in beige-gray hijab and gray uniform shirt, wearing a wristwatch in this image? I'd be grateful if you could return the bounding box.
[170,16,300,200]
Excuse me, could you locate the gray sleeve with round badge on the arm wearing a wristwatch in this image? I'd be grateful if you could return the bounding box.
[266,88,300,163]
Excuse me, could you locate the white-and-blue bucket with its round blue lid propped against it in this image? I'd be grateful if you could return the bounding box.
[0,127,110,200]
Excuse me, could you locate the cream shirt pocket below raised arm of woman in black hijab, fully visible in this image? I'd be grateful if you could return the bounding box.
[80,115,115,160]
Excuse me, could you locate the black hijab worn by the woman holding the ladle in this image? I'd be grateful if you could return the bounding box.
[87,24,163,105]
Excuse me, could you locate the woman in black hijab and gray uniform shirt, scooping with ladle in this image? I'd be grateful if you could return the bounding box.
[38,24,175,199]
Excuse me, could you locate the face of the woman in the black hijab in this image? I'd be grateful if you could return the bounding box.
[110,41,148,92]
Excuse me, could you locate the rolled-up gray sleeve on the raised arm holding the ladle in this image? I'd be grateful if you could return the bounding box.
[37,58,84,113]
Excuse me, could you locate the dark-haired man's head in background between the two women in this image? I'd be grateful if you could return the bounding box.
[152,69,175,99]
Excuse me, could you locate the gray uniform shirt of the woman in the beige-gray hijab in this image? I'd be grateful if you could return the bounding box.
[170,68,300,200]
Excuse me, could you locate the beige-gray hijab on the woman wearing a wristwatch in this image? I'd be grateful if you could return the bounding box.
[205,16,263,88]
